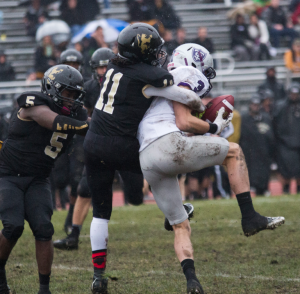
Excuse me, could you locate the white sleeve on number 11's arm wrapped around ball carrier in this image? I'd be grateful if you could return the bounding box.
[143,85,205,112]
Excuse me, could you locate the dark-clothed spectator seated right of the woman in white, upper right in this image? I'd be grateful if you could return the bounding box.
[262,0,298,48]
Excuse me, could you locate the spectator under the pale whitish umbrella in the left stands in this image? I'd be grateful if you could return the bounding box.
[35,36,56,79]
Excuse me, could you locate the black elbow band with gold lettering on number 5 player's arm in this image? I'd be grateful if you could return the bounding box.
[52,115,89,136]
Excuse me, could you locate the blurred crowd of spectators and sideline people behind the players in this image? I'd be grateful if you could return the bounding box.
[0,0,300,207]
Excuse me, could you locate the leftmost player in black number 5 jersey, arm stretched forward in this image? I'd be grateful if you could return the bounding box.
[0,65,88,294]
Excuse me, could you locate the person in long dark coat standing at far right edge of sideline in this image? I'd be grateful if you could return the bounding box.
[273,82,300,194]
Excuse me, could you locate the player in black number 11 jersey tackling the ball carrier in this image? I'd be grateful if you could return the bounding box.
[84,23,203,294]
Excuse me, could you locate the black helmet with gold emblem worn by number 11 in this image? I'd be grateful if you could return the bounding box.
[118,23,167,66]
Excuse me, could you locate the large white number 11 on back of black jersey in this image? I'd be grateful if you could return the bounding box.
[95,68,123,114]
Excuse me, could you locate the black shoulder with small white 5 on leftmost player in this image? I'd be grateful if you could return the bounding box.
[17,91,53,108]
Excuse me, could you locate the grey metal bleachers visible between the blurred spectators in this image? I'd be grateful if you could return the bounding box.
[0,0,288,107]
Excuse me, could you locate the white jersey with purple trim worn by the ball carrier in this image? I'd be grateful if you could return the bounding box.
[137,66,209,152]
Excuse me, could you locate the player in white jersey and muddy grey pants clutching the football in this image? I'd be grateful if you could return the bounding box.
[137,44,285,293]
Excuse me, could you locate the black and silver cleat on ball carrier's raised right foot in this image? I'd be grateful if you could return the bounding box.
[242,212,285,237]
